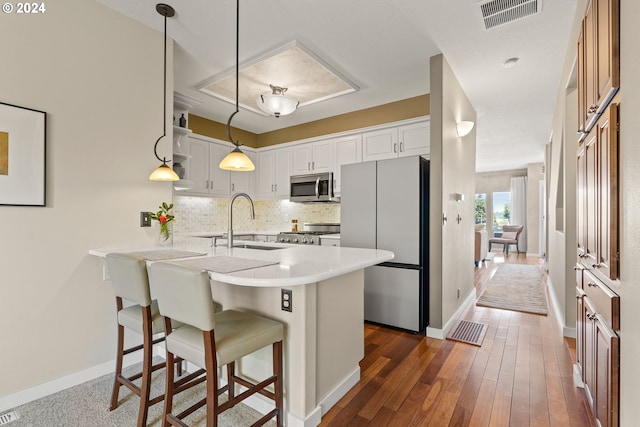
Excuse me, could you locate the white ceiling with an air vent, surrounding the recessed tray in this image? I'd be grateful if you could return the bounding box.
[98,0,577,172]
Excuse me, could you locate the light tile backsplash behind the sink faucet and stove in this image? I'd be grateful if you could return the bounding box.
[173,196,340,233]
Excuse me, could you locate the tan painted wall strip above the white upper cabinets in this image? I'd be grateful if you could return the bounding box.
[189,94,429,148]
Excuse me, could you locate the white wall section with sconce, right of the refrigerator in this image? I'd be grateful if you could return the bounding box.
[429,55,476,333]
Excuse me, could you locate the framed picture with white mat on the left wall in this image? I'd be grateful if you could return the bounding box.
[0,102,47,206]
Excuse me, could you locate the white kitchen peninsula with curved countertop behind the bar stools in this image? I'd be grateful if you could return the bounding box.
[90,238,393,426]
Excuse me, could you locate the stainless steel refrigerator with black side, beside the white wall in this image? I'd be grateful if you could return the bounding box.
[340,156,429,334]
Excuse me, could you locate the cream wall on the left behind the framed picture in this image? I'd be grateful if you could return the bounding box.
[0,0,173,399]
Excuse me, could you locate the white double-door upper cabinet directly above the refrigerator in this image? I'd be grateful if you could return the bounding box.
[362,121,429,162]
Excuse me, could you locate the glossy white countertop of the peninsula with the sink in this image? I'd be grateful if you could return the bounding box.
[89,238,394,287]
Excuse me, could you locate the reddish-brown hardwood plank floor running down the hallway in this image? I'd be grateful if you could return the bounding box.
[321,252,595,426]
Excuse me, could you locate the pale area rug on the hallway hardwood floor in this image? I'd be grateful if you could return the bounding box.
[476,264,548,316]
